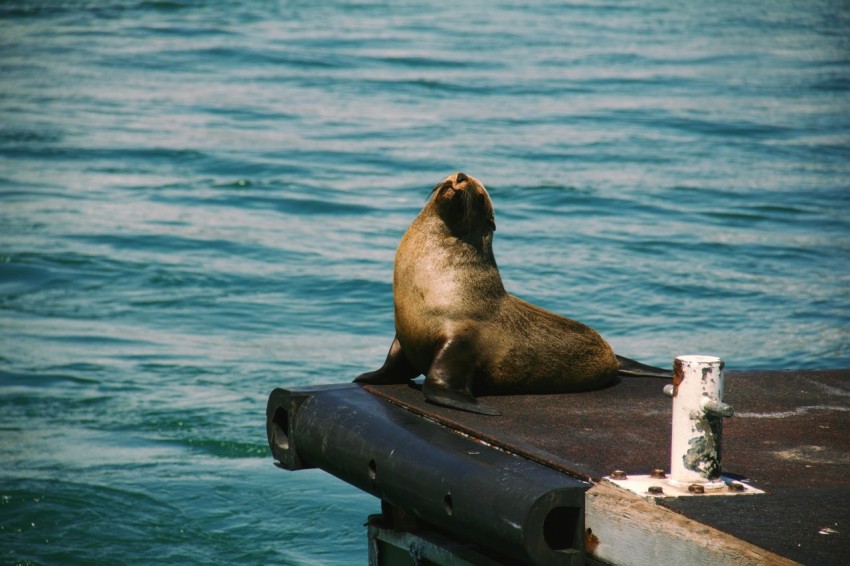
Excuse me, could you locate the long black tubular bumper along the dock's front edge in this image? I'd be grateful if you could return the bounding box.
[266,384,590,565]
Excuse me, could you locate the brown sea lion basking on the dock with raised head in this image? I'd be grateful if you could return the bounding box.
[354,173,672,415]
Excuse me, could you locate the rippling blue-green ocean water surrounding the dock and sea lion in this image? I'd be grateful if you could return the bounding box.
[0,0,850,564]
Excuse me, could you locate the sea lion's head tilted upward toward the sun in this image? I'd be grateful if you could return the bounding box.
[430,173,496,240]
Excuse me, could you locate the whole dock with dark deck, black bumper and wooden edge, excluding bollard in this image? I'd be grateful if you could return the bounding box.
[267,370,850,566]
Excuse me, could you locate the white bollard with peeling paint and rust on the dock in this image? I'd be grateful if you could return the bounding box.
[664,356,733,489]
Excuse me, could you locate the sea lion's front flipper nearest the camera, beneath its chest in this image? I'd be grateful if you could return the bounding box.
[422,338,502,416]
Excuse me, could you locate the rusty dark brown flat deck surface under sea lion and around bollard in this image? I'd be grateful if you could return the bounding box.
[364,370,850,565]
